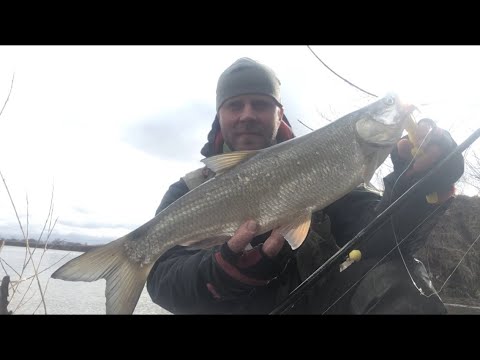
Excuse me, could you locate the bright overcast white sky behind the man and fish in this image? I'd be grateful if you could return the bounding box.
[0,46,480,243]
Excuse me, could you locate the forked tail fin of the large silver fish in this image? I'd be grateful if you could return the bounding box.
[51,236,153,314]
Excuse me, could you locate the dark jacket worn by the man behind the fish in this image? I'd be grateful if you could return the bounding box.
[147,116,463,314]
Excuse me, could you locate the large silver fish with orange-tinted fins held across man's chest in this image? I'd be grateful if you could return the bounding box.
[52,94,413,314]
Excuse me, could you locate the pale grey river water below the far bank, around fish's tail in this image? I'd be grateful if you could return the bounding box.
[0,246,170,315]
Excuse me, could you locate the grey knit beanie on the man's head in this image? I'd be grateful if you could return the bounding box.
[217,57,282,112]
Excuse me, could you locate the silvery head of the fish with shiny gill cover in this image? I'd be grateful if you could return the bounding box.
[355,93,416,148]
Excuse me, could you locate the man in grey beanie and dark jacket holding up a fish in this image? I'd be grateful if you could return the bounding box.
[147,58,463,314]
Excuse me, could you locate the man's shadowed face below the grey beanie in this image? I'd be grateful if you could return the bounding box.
[218,95,283,151]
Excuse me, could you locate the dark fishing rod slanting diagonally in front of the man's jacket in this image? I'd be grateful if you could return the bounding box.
[270,128,480,315]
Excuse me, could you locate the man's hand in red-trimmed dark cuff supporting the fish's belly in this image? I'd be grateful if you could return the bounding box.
[207,220,288,299]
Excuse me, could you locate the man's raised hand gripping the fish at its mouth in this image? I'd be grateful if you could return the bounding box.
[390,119,464,203]
